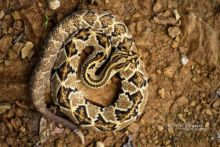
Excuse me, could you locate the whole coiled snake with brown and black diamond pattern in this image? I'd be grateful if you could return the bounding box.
[30,10,148,142]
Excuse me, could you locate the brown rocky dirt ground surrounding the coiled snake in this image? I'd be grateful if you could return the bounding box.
[0,0,220,147]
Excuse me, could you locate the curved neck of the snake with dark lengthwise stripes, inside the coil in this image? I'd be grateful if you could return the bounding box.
[80,51,127,88]
